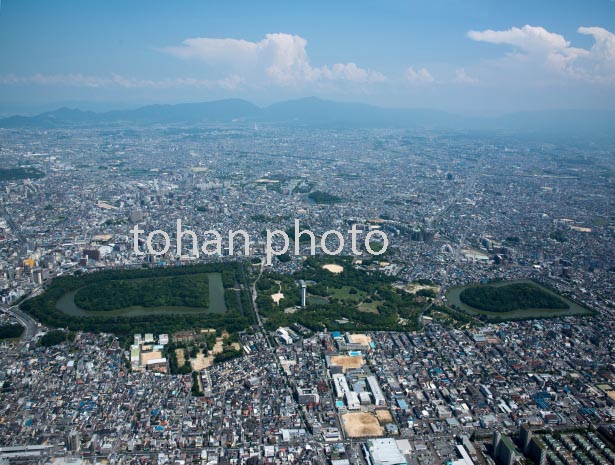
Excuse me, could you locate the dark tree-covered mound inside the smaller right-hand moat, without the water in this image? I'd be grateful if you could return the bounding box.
[459,283,569,312]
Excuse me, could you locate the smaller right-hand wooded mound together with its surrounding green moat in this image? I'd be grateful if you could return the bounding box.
[446,280,594,321]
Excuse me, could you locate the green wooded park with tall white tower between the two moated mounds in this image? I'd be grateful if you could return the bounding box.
[256,257,425,331]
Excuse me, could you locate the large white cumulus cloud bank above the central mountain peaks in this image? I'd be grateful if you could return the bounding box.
[162,33,386,86]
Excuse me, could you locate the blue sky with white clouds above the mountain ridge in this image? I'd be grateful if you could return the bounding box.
[0,0,615,114]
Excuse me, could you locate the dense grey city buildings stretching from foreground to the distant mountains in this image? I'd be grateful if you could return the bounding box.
[0,120,615,465]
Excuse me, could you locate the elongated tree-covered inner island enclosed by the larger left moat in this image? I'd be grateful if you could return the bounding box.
[75,274,209,311]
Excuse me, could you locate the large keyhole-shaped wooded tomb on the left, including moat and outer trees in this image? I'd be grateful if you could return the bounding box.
[21,263,254,334]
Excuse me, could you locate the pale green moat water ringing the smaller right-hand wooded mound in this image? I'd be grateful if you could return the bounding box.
[446,280,595,321]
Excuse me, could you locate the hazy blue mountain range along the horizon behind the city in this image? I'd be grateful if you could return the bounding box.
[0,97,615,136]
